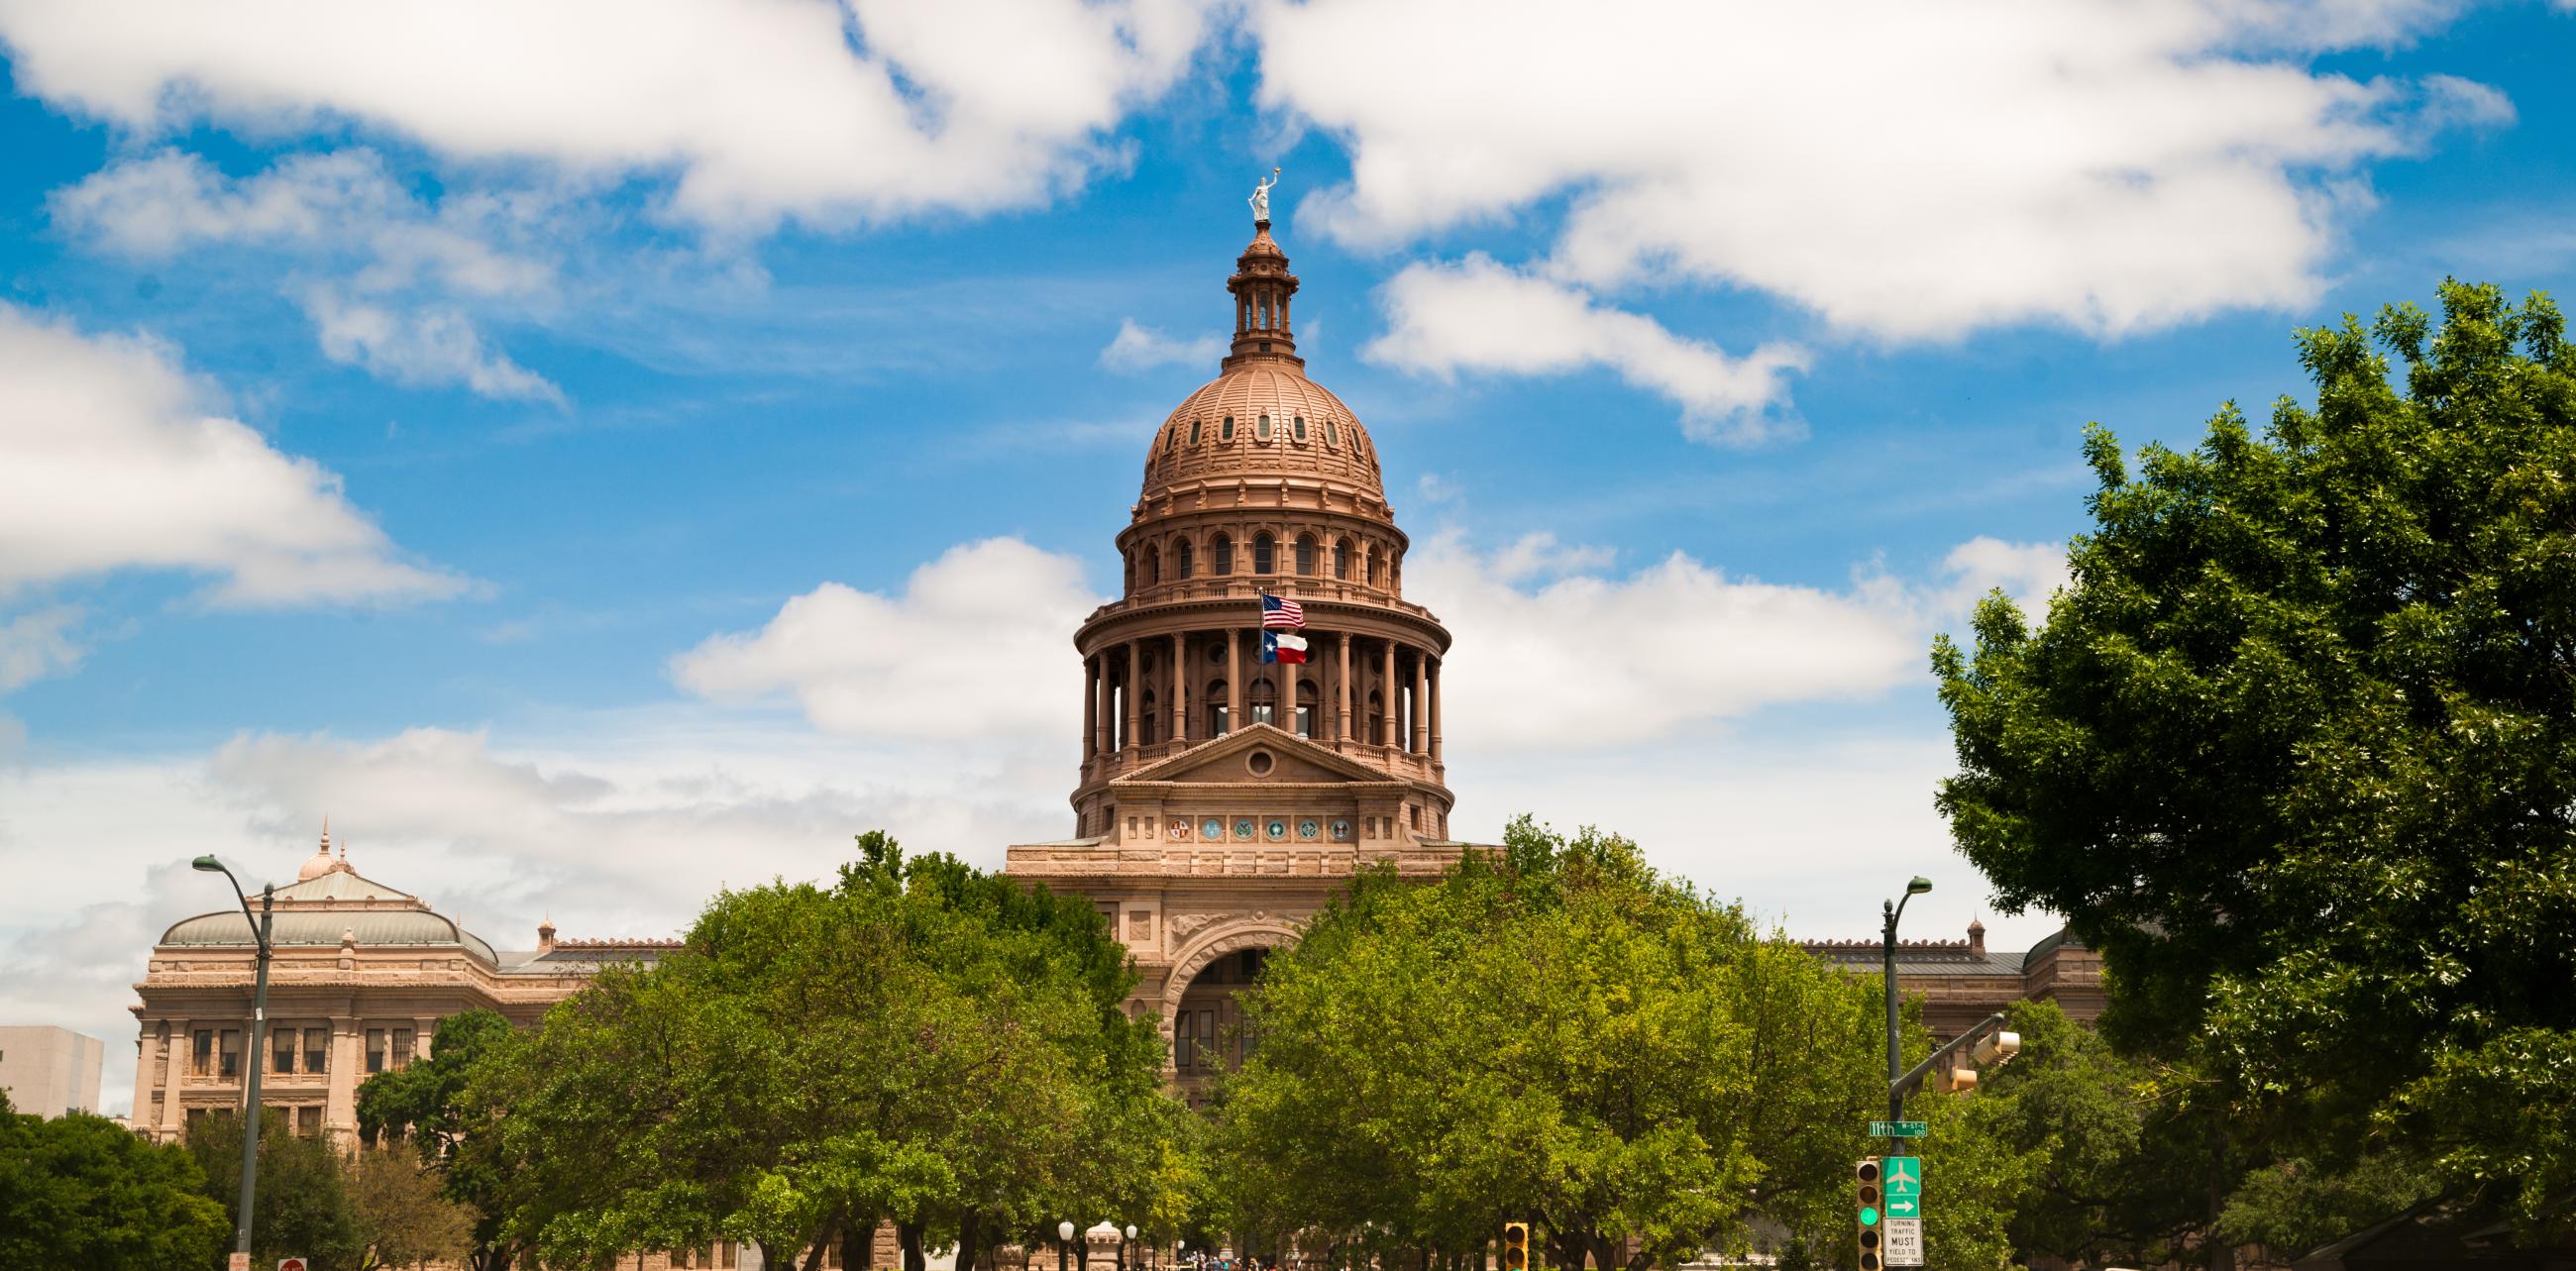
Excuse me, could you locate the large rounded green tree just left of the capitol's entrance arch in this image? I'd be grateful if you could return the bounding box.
[467,835,1164,1271]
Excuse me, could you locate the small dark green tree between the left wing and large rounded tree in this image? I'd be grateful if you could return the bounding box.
[358,1010,525,1271]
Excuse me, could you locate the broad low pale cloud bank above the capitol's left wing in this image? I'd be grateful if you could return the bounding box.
[0,714,1072,1109]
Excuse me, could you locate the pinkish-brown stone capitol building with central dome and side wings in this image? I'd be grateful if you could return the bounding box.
[134,206,2099,1139]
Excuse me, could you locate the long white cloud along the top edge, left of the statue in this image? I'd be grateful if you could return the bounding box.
[0,0,1206,227]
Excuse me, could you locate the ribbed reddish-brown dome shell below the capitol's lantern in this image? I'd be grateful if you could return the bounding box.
[1143,361,1386,500]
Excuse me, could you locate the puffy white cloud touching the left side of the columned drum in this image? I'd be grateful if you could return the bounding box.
[673,539,1103,745]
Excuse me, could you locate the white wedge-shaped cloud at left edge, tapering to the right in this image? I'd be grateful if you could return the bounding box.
[0,304,467,606]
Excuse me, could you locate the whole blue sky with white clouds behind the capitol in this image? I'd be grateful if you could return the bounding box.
[0,0,2576,1101]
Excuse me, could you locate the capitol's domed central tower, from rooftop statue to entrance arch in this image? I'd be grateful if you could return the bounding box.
[1008,203,1460,1099]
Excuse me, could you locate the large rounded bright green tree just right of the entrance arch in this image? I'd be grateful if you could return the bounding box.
[1219,817,1885,1266]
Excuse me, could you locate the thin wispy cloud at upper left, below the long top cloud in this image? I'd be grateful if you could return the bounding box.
[52,150,564,405]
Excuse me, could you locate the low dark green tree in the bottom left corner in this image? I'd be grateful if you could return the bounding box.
[0,1093,232,1271]
